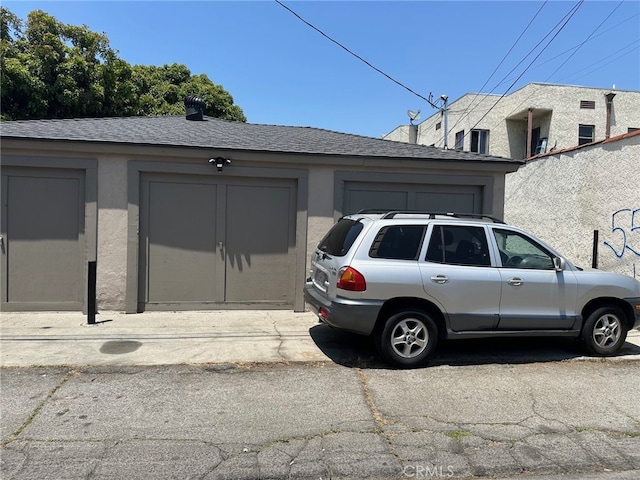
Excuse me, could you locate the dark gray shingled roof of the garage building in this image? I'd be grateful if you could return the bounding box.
[0,116,522,163]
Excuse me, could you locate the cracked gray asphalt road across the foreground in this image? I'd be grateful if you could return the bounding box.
[0,358,640,480]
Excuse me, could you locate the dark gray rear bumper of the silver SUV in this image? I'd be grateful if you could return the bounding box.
[304,282,383,335]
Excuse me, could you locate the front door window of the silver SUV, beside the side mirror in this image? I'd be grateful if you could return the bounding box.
[493,228,554,270]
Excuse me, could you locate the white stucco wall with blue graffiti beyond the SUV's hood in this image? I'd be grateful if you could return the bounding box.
[505,134,640,278]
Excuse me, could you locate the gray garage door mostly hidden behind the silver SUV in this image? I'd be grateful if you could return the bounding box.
[343,182,482,214]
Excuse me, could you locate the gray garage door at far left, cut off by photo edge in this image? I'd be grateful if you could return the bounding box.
[0,168,85,310]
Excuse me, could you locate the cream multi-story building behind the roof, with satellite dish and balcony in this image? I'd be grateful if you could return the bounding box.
[384,83,640,159]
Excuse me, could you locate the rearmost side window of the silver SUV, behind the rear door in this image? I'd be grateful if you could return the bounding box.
[369,225,426,260]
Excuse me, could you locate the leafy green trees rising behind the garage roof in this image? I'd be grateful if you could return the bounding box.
[0,7,246,122]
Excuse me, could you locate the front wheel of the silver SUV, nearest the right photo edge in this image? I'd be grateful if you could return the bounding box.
[582,305,627,357]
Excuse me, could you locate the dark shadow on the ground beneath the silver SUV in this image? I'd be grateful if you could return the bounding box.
[309,324,640,368]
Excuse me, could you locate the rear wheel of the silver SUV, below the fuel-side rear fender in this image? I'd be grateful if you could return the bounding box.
[376,309,438,368]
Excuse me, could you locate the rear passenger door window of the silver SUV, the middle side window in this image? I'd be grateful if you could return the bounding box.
[426,225,491,267]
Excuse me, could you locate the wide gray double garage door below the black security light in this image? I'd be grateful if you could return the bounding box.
[138,174,297,311]
